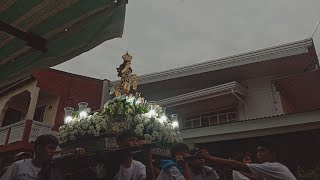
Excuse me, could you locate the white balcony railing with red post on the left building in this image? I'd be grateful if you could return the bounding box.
[0,120,56,152]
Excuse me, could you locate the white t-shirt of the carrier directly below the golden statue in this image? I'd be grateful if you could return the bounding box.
[114,160,147,180]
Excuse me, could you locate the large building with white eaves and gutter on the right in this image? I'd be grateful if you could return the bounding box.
[109,39,320,174]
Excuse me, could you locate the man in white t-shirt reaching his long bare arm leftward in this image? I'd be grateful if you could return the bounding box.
[198,143,296,180]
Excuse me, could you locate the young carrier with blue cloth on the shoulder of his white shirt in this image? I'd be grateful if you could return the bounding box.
[157,143,192,180]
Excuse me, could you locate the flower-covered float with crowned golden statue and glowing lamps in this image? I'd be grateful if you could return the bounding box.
[58,53,181,152]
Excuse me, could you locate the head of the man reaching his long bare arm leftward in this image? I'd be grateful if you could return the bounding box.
[257,142,277,163]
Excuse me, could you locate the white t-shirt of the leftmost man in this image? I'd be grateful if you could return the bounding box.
[1,159,41,180]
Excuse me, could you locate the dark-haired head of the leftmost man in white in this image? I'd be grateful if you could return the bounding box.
[34,134,59,162]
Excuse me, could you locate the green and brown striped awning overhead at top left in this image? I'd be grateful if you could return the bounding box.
[0,0,127,86]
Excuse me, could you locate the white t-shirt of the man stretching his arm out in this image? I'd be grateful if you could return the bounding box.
[248,162,297,180]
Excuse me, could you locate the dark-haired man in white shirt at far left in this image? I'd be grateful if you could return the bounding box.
[1,134,59,180]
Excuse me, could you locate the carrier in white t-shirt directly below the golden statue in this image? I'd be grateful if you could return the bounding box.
[114,130,154,180]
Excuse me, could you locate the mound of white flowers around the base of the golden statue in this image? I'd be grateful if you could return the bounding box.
[58,97,182,146]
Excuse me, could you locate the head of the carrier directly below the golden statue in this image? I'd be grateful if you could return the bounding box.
[117,129,139,147]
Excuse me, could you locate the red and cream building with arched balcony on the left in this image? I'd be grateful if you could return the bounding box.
[0,69,103,155]
